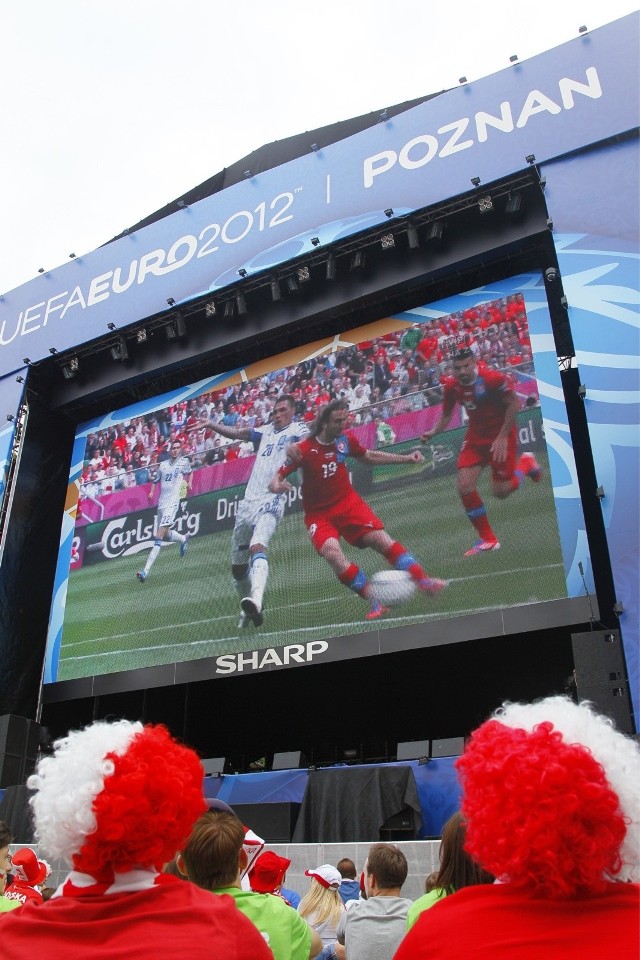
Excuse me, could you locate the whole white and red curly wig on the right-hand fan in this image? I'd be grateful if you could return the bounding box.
[457,696,640,898]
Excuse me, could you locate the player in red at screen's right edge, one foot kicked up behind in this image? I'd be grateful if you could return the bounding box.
[421,348,542,557]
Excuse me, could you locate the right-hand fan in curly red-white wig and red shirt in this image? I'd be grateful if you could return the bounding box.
[394,697,640,960]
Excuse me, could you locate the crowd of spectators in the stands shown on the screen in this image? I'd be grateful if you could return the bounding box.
[81,294,533,498]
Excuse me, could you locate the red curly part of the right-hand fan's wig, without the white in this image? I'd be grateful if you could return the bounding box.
[457,719,626,898]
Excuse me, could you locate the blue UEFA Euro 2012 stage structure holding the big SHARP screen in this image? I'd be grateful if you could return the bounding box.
[0,15,640,769]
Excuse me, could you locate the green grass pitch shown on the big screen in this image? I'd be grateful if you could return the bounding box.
[58,452,566,680]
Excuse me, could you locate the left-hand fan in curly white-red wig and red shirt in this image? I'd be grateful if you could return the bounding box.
[2,720,272,960]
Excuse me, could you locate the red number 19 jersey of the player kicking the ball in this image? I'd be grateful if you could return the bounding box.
[278,431,367,510]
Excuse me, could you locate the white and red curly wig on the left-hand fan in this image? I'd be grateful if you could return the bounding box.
[28,720,206,877]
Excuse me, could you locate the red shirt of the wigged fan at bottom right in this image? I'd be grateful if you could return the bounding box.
[392,883,640,960]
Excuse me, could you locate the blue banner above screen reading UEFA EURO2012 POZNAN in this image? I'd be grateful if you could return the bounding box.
[0,14,639,375]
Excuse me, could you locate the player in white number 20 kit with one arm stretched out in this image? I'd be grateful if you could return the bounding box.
[202,395,309,628]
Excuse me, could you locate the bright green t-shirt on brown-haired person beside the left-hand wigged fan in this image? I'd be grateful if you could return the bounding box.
[215,887,311,960]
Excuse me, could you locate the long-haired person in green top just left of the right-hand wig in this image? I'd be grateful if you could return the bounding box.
[407,811,494,930]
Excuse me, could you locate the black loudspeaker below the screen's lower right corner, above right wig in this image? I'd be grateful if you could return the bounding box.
[571,630,634,734]
